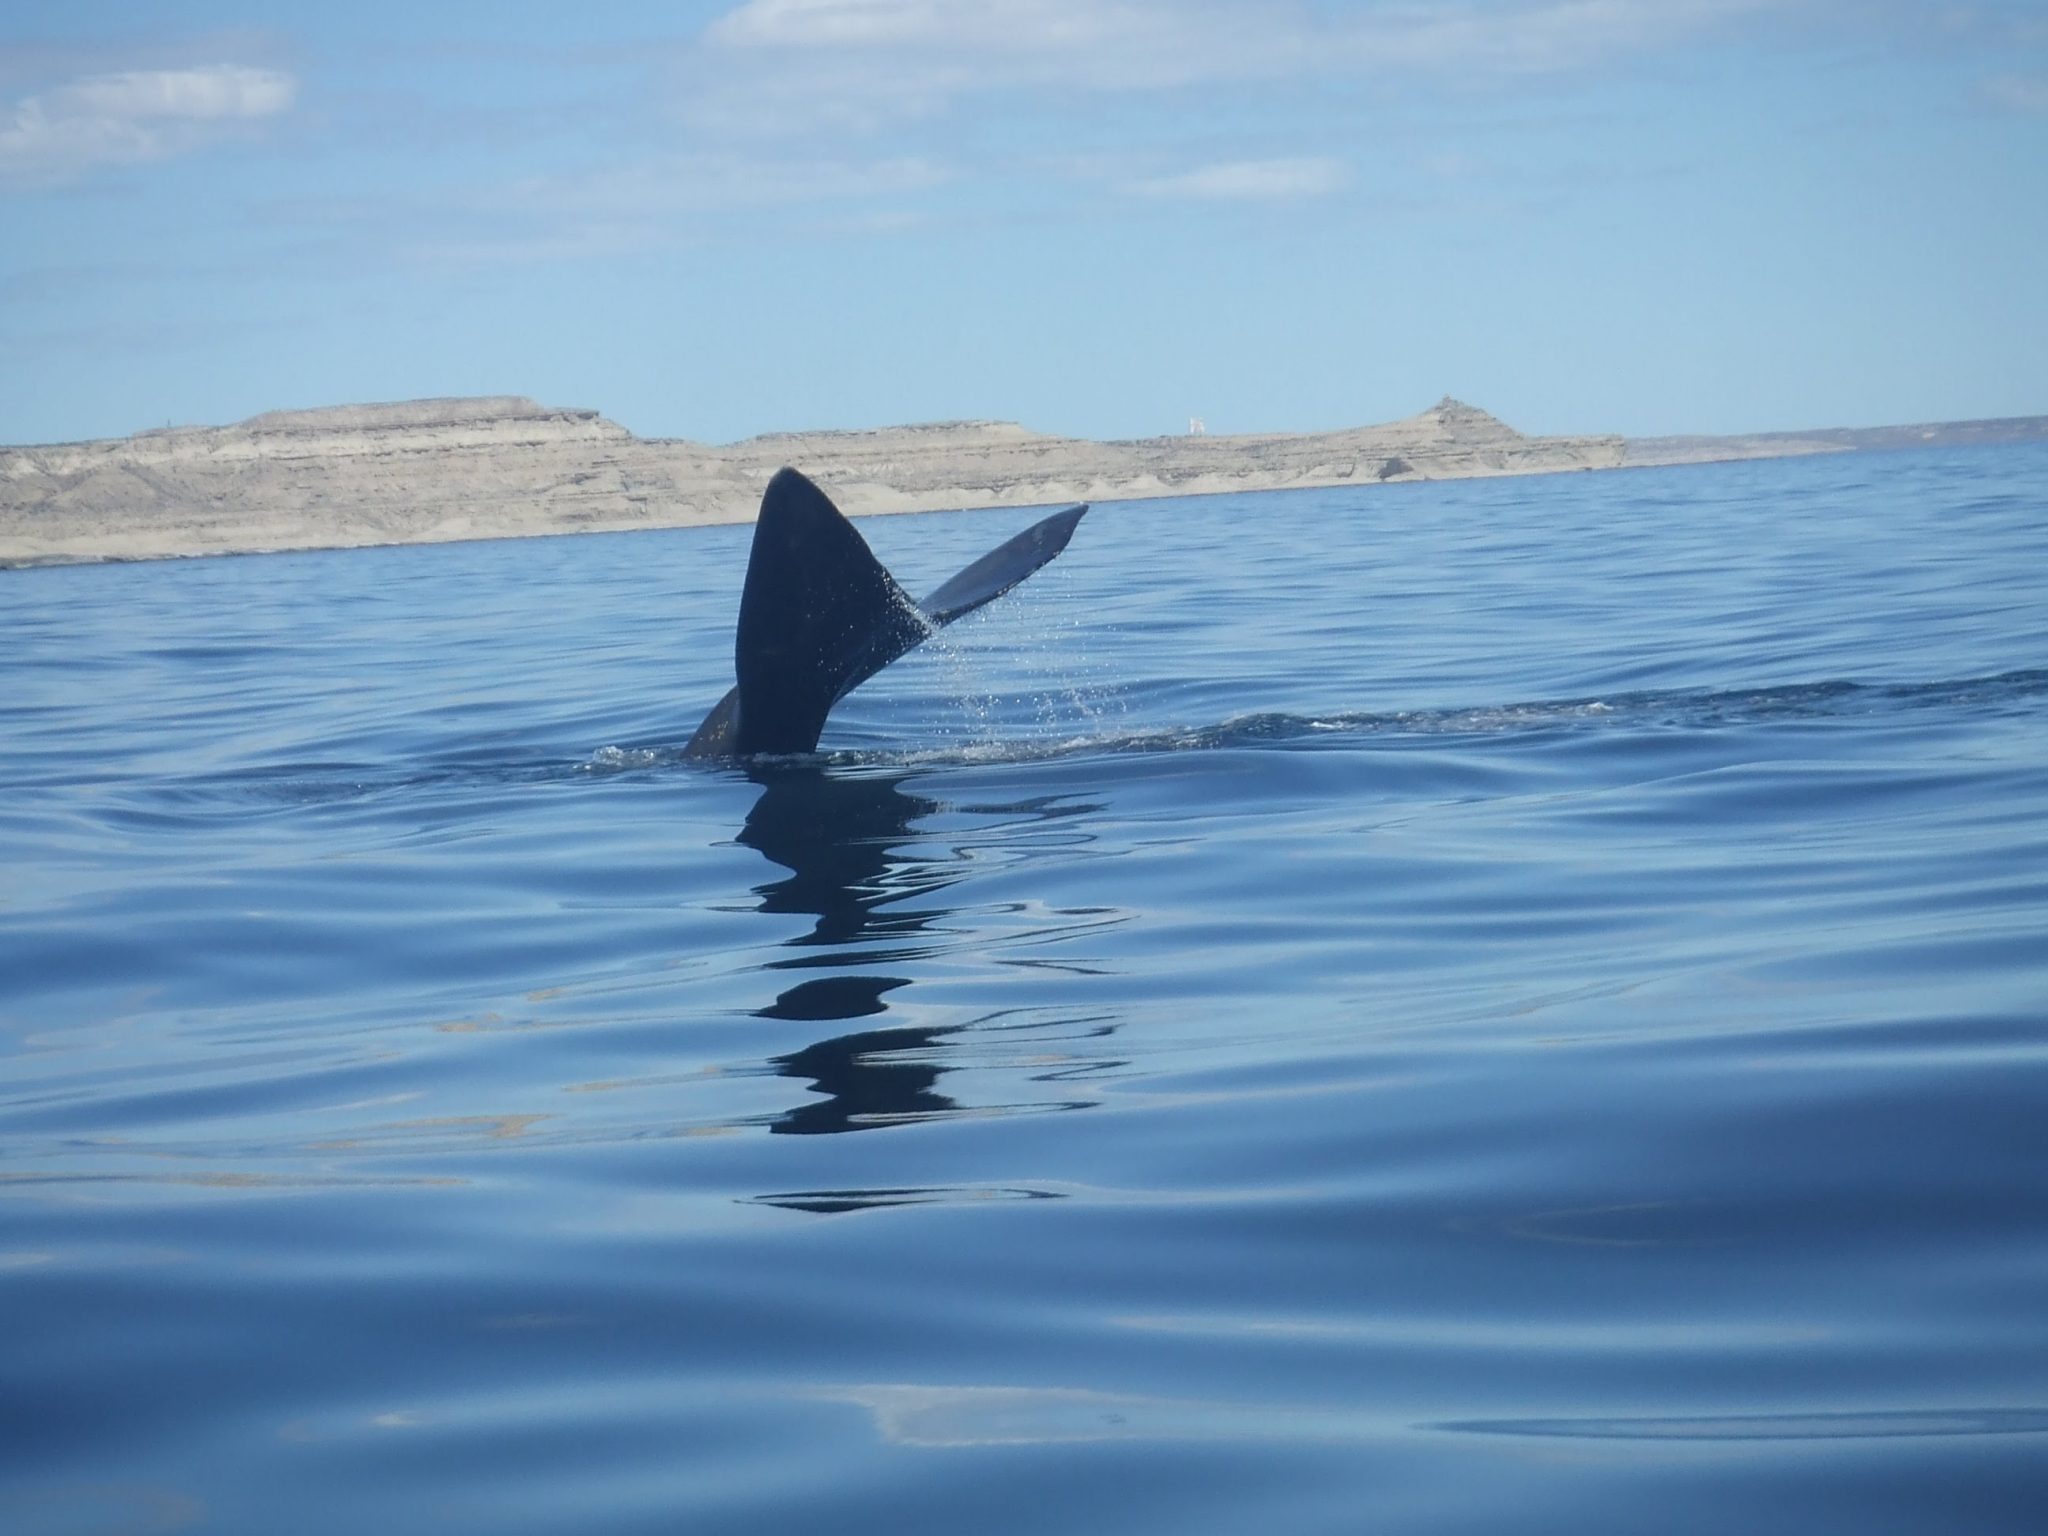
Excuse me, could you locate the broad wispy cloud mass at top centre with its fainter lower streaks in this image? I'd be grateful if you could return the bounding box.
[280,0,1804,266]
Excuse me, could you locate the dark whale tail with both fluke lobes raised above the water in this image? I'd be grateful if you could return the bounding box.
[684,469,1087,758]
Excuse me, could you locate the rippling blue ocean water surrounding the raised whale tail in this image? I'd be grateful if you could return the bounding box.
[0,446,2048,1536]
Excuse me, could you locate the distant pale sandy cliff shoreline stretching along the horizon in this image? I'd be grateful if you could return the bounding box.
[0,395,2048,567]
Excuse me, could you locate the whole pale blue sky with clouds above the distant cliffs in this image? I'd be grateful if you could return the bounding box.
[0,0,2048,442]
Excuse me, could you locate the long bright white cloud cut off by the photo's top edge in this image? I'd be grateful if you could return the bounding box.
[680,0,1806,137]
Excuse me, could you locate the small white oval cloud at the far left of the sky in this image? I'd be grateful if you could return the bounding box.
[0,63,299,184]
